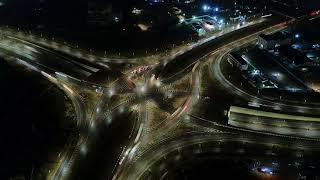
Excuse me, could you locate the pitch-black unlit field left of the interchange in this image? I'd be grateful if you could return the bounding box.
[0,59,75,179]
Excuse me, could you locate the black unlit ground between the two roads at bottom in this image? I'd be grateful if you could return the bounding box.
[68,109,135,179]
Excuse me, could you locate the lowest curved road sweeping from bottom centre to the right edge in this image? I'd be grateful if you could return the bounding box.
[122,134,320,179]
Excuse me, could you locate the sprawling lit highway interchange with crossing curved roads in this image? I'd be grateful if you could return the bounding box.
[0,14,320,179]
